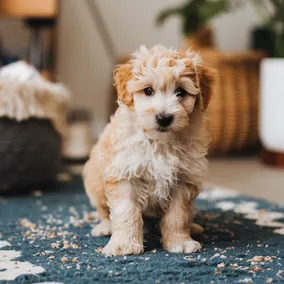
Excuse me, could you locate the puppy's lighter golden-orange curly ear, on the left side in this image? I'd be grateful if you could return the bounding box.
[113,62,133,107]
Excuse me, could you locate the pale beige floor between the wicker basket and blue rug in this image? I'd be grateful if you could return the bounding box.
[206,157,284,204]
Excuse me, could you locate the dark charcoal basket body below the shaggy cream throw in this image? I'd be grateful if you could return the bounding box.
[0,117,61,194]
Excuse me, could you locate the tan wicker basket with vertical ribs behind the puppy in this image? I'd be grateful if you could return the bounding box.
[200,49,263,155]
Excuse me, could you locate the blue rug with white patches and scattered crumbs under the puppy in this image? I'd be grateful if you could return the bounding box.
[0,177,284,284]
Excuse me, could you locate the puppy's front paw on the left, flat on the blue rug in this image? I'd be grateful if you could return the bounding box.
[102,239,144,256]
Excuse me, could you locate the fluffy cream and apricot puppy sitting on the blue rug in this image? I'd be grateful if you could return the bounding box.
[84,45,215,255]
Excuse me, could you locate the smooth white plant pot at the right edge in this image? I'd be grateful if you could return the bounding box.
[260,58,284,153]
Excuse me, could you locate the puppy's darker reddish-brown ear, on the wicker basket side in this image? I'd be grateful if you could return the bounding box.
[198,65,217,110]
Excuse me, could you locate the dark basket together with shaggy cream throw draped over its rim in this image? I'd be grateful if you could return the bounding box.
[0,76,69,194]
